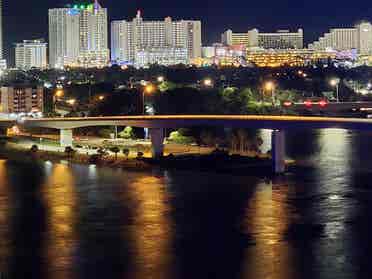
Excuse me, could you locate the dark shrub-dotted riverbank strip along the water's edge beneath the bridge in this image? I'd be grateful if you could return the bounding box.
[0,143,284,176]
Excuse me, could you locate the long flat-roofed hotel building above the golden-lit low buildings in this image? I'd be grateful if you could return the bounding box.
[221,29,304,49]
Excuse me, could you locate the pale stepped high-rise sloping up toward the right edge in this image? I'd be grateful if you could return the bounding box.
[308,22,372,55]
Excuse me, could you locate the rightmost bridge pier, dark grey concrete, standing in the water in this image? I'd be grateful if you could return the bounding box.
[271,130,285,174]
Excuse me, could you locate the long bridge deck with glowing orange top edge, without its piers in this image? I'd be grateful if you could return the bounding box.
[19,115,372,130]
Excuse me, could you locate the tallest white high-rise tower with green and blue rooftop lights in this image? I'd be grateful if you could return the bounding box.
[49,0,109,68]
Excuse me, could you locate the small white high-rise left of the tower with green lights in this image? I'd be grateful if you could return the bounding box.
[15,40,47,70]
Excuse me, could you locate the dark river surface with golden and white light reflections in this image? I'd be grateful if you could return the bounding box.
[0,130,372,279]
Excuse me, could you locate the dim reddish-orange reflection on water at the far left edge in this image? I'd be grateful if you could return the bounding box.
[0,160,10,271]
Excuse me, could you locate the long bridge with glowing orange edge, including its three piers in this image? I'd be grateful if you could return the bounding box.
[9,115,372,173]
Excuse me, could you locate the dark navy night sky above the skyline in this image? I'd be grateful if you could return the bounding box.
[3,0,372,64]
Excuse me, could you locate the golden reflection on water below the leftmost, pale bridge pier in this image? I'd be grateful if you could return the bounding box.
[43,164,77,278]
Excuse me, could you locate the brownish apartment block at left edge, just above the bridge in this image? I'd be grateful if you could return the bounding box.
[1,85,44,114]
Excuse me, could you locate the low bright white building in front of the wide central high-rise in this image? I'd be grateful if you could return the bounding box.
[135,47,188,68]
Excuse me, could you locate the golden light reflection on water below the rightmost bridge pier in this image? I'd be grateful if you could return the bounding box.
[243,183,295,279]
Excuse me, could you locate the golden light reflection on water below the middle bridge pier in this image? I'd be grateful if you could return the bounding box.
[129,176,172,278]
